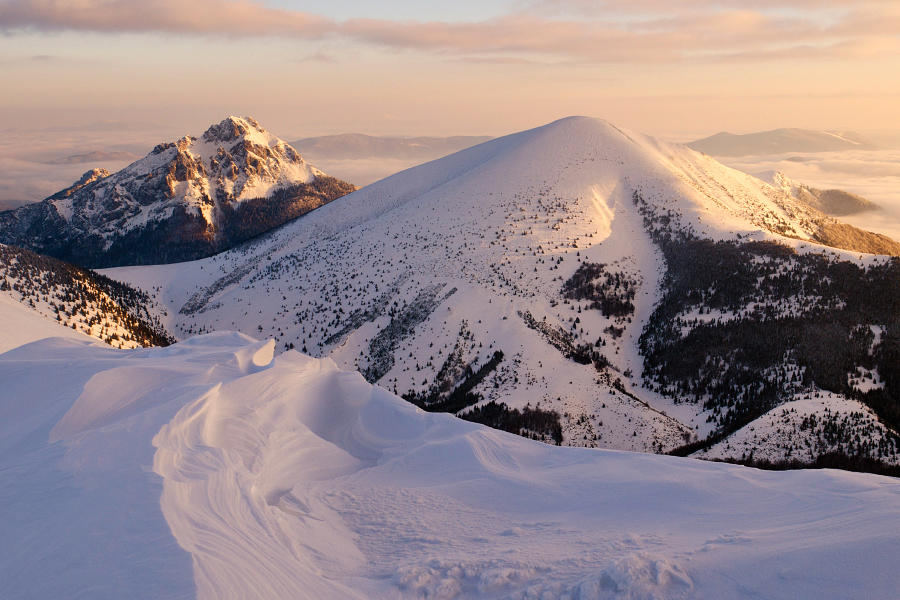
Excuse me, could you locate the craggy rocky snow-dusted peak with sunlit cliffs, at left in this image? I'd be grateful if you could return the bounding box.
[0,117,355,267]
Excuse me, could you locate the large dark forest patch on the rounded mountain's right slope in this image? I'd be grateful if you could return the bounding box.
[634,192,900,461]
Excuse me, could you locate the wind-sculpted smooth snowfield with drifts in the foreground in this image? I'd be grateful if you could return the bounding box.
[0,332,900,600]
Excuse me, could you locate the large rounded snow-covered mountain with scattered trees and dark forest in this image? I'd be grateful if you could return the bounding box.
[108,117,900,463]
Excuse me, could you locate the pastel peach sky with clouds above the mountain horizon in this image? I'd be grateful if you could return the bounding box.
[0,0,900,140]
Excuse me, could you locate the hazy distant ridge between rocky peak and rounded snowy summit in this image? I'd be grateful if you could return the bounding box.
[291,133,492,160]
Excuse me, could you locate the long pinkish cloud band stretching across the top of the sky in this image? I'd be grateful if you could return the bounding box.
[0,0,900,62]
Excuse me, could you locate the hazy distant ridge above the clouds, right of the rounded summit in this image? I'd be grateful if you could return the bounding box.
[687,129,878,156]
